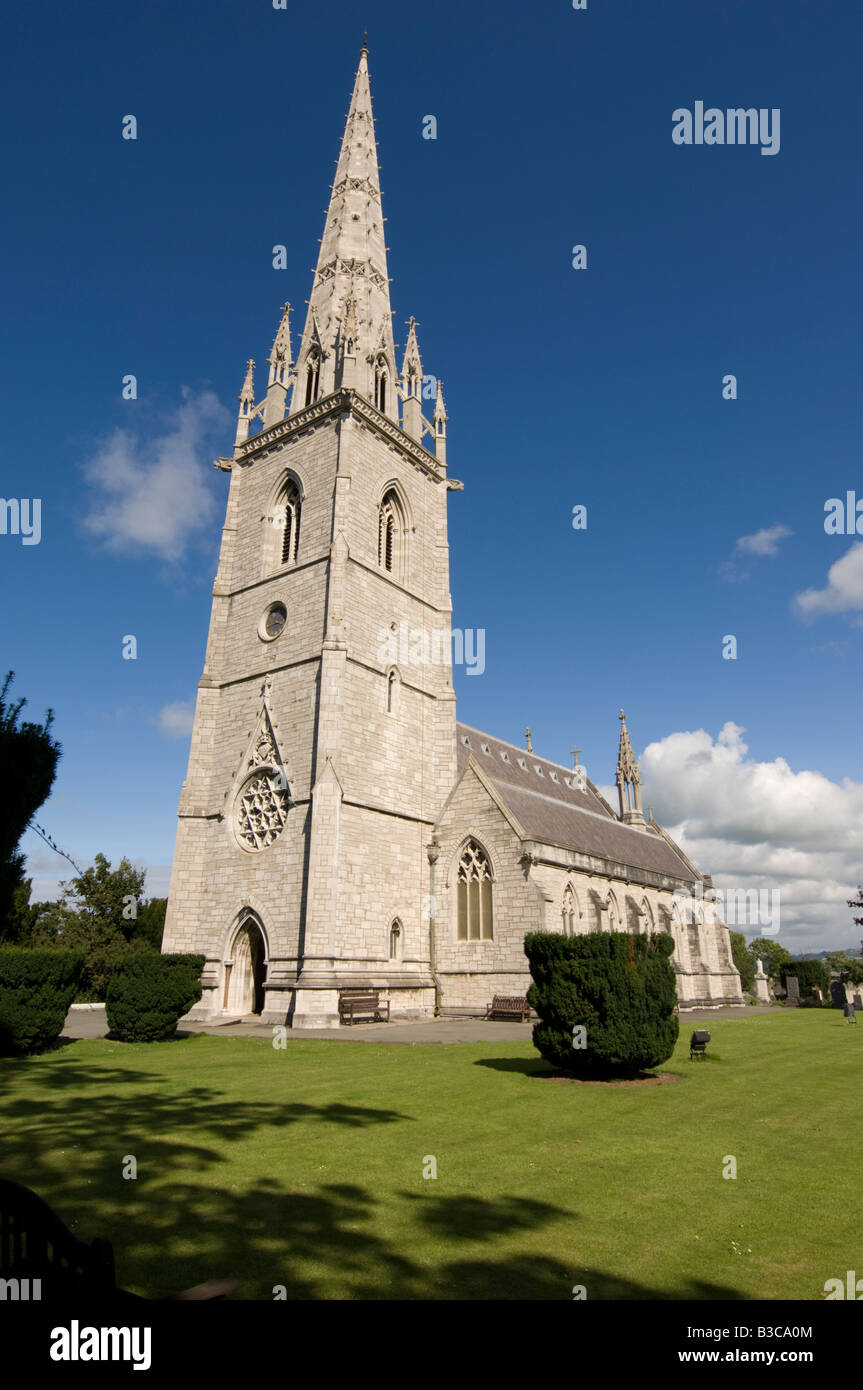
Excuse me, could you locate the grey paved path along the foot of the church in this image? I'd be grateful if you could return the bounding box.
[63,1005,771,1043]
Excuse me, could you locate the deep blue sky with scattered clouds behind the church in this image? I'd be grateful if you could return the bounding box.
[0,0,863,949]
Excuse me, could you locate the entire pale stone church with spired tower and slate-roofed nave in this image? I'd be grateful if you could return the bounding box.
[164,49,742,1029]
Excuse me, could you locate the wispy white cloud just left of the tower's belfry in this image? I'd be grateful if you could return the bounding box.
[85,391,229,560]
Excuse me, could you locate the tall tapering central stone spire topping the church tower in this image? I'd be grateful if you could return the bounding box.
[290,46,399,421]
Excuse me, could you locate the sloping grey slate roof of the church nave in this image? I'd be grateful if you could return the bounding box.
[456,724,695,883]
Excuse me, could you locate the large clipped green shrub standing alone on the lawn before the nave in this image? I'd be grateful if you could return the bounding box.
[524,931,678,1077]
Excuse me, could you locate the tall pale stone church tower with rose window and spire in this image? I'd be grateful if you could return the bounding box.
[164,47,456,1027]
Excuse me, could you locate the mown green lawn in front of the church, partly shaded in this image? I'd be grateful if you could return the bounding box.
[0,1009,863,1300]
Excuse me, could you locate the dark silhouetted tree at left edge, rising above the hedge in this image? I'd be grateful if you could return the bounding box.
[0,671,61,940]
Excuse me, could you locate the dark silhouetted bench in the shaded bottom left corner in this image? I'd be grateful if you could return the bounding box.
[0,1177,238,1302]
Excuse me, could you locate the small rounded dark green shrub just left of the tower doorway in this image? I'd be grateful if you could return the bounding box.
[106,952,204,1043]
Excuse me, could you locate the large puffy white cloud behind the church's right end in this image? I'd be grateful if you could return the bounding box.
[641,721,863,951]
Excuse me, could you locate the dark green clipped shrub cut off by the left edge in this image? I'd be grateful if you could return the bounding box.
[0,947,85,1056]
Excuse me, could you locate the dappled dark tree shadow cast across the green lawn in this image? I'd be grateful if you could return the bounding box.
[0,1054,742,1300]
